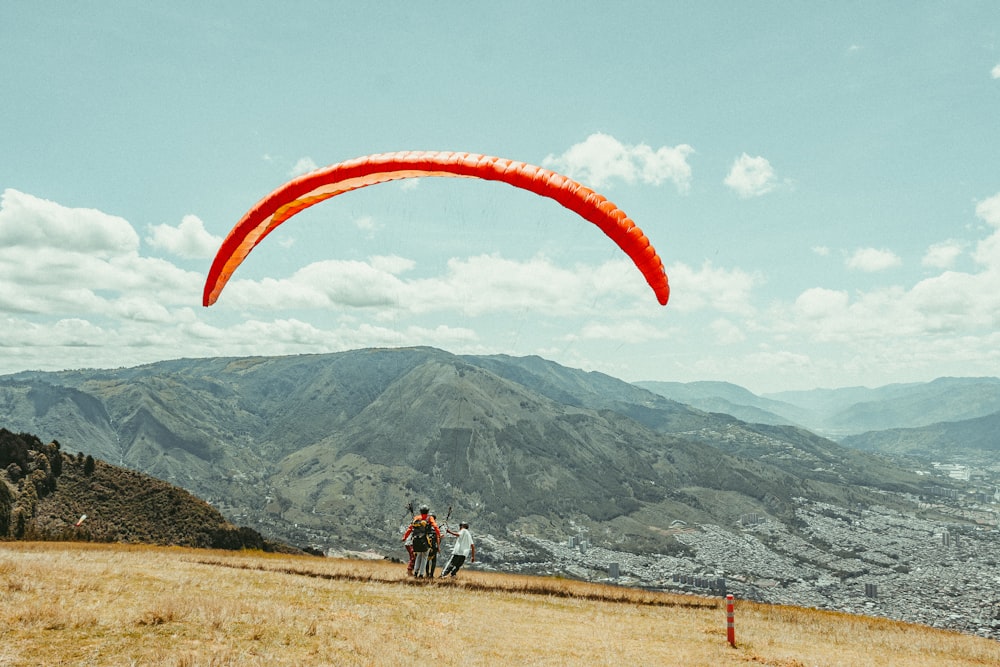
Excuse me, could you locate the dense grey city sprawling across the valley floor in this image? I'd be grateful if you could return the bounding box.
[478,459,1000,639]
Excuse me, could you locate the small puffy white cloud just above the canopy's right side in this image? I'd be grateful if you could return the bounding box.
[542,133,694,192]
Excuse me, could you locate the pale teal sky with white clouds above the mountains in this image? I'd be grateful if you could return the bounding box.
[0,0,1000,394]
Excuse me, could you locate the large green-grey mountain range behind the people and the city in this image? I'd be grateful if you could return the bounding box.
[0,348,972,553]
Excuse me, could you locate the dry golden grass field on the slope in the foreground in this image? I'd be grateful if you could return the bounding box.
[0,542,1000,667]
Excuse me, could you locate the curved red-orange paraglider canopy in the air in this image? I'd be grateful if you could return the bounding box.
[202,151,670,306]
